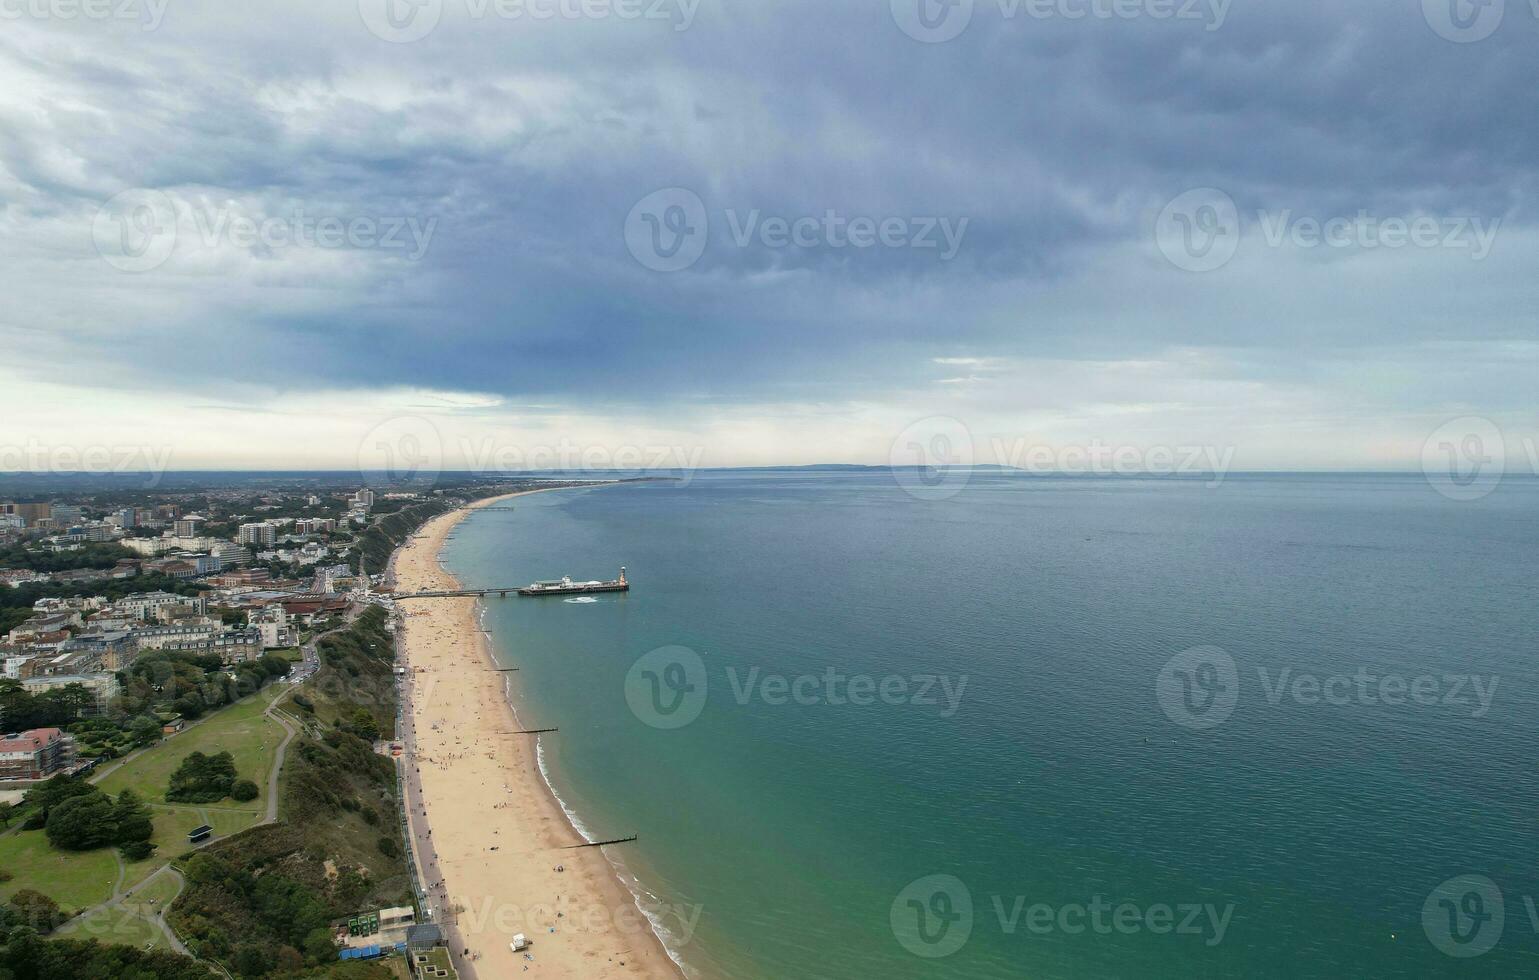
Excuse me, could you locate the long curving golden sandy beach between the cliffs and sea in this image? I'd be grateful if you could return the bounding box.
[392,491,682,980]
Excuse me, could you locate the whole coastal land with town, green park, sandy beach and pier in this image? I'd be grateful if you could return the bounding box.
[0,478,676,980]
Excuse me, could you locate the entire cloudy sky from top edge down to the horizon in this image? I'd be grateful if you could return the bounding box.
[0,0,1539,471]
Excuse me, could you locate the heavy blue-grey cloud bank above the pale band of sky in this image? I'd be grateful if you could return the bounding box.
[0,0,1539,405]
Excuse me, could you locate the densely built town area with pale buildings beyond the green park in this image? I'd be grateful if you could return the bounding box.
[0,488,397,732]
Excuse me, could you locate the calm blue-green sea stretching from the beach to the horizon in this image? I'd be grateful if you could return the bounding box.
[446,471,1539,980]
